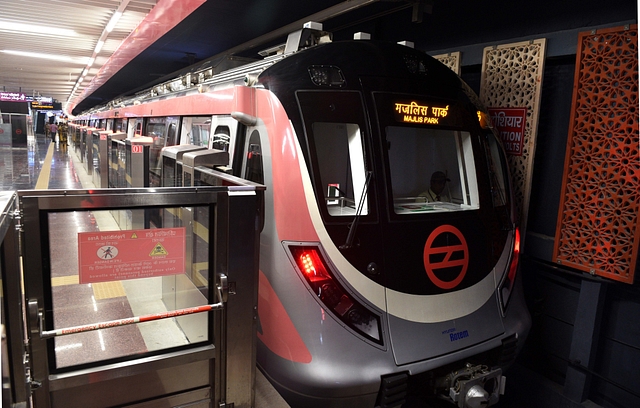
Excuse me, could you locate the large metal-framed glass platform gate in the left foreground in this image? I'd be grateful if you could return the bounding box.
[0,183,264,408]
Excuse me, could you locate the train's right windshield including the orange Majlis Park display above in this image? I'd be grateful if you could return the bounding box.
[374,92,480,216]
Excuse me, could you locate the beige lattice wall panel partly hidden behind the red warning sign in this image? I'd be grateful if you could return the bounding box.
[480,38,546,236]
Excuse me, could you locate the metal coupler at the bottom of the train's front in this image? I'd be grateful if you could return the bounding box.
[438,364,506,408]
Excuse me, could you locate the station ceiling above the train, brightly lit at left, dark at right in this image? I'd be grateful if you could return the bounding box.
[0,0,638,114]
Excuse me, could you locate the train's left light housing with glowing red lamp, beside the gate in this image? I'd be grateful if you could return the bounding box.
[289,245,382,344]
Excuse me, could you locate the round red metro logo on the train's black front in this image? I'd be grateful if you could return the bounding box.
[424,225,469,289]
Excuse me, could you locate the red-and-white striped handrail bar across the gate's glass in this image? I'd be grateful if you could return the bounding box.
[38,274,228,339]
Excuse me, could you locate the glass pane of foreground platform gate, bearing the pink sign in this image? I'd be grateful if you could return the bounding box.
[47,206,215,369]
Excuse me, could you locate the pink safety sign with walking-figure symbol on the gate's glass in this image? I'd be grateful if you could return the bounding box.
[78,227,186,283]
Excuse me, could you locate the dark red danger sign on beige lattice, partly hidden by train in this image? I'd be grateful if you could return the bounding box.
[489,108,527,156]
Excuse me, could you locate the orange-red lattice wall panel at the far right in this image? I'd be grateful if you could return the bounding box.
[553,26,640,283]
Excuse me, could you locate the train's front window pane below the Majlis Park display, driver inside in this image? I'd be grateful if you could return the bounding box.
[386,126,479,214]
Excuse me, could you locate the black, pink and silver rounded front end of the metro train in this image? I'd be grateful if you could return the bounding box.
[258,41,530,407]
